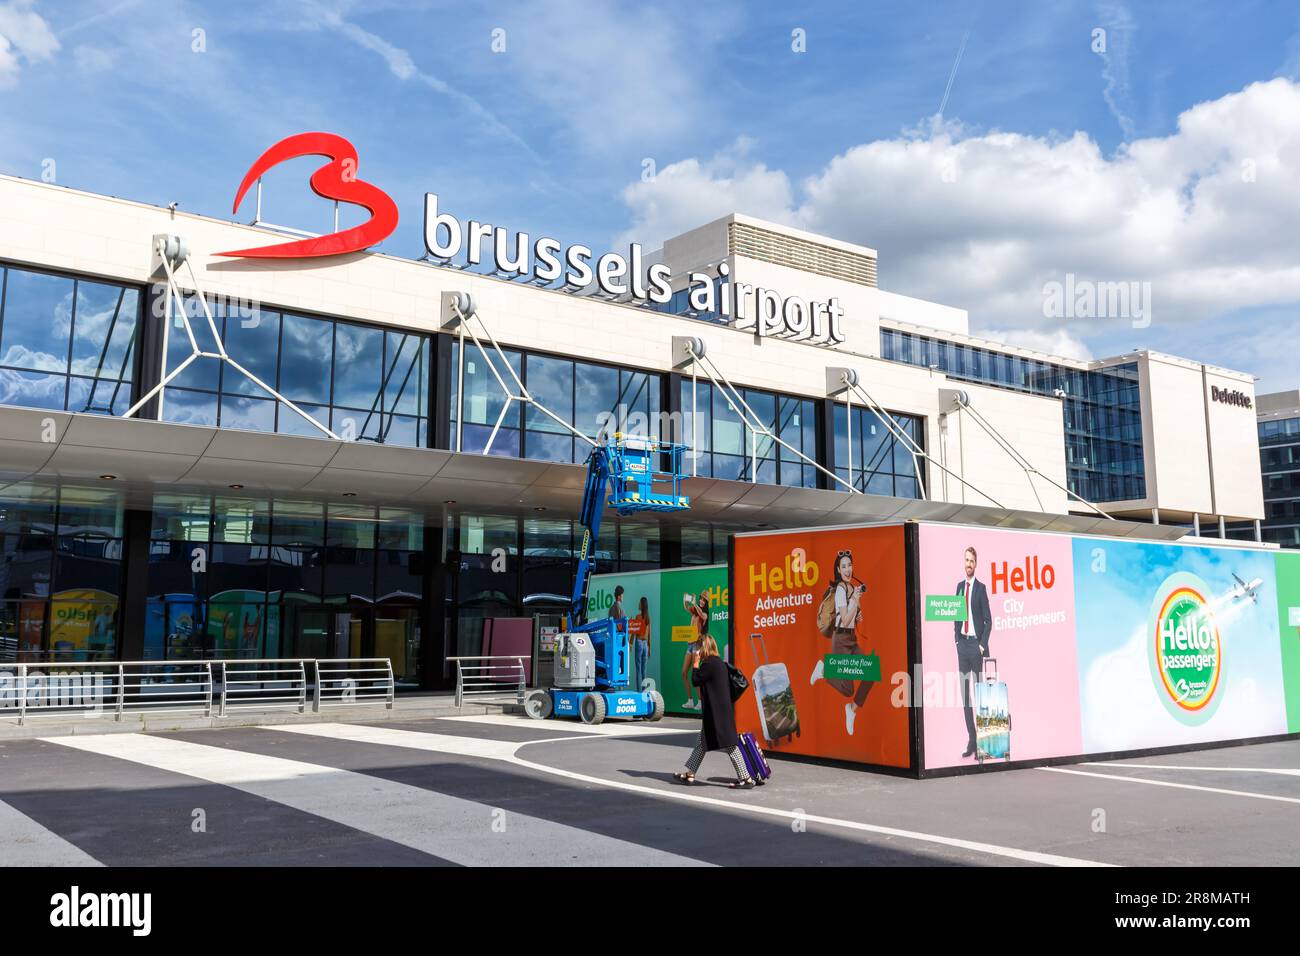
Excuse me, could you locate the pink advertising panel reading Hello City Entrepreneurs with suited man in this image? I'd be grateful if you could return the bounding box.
[919,524,1083,770]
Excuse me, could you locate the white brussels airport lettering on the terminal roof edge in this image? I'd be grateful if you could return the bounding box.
[424,193,844,345]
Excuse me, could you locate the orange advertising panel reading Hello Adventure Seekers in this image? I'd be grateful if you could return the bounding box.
[732,525,910,767]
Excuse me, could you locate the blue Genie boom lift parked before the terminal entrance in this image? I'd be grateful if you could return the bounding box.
[524,433,690,723]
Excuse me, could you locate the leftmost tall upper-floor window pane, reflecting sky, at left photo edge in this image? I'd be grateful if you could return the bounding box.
[0,269,73,374]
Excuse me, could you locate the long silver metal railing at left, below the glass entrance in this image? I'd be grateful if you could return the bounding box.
[0,657,397,724]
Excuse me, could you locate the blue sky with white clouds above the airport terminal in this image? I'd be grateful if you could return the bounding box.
[0,0,1300,389]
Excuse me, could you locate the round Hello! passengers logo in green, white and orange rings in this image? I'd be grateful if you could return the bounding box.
[1147,571,1223,726]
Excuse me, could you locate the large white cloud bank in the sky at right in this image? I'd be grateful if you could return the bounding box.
[623,78,1300,350]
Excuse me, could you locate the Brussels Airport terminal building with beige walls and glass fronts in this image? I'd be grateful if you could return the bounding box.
[0,170,1264,687]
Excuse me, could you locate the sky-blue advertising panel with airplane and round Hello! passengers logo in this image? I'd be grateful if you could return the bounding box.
[1074,537,1287,753]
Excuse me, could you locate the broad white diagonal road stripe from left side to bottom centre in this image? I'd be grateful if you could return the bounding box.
[48,724,707,866]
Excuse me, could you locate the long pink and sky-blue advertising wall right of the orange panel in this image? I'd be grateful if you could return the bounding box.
[918,524,1300,770]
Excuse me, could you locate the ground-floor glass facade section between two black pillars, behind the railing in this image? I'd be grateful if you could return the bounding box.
[144,494,424,683]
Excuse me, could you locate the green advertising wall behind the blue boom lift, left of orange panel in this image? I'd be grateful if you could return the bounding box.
[588,564,731,714]
